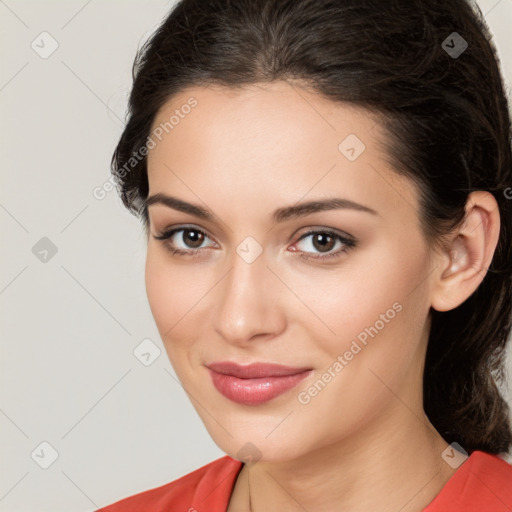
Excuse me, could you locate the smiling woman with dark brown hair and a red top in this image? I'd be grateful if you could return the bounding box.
[97,0,512,512]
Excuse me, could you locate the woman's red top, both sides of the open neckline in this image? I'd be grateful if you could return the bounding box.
[96,451,512,512]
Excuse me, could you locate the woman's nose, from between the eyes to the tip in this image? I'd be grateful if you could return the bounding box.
[215,240,279,343]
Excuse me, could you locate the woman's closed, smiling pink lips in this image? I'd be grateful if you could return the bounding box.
[207,361,312,405]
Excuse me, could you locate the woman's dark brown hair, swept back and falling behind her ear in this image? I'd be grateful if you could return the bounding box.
[112,0,512,453]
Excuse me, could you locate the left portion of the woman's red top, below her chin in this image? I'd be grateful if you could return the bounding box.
[96,455,243,512]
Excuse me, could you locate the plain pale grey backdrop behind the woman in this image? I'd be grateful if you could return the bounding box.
[0,0,512,512]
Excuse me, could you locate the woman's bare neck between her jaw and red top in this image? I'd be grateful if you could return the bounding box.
[237,404,454,512]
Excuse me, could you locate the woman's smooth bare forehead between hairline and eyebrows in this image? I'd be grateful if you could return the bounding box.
[148,81,415,222]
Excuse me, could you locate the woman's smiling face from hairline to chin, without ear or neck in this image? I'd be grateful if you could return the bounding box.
[146,82,431,461]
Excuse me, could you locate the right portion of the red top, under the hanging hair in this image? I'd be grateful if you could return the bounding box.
[424,451,512,512]
